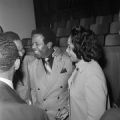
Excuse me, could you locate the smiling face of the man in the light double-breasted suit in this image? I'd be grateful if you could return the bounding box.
[32,34,49,58]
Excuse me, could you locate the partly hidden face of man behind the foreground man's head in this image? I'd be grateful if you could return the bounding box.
[14,40,25,57]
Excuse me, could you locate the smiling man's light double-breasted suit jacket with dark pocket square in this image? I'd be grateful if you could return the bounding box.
[20,53,73,120]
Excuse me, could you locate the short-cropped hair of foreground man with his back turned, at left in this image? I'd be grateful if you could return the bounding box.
[0,35,19,72]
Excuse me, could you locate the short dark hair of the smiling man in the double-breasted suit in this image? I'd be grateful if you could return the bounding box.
[31,27,56,46]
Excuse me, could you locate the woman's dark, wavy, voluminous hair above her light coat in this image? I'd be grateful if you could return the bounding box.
[70,26,102,62]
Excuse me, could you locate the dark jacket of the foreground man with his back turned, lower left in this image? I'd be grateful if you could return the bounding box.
[0,81,48,120]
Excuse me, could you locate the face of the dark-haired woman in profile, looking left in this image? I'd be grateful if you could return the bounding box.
[66,36,78,62]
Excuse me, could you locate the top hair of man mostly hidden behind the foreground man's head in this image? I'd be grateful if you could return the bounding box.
[3,31,20,41]
